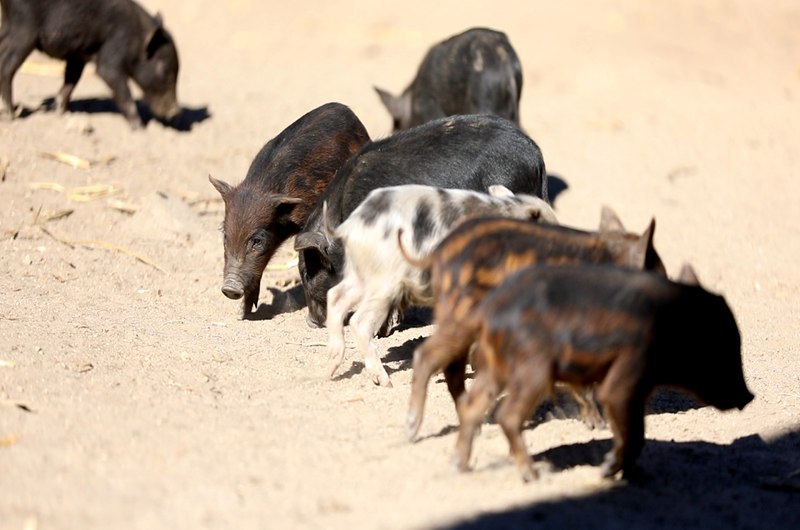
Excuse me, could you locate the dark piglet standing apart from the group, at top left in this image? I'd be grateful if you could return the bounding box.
[0,0,180,129]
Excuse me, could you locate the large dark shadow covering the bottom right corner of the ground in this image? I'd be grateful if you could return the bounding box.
[437,428,800,530]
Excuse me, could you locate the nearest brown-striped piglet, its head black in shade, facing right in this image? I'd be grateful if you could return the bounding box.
[450,265,754,482]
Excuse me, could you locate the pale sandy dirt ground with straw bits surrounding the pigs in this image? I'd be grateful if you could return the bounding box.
[0,0,800,530]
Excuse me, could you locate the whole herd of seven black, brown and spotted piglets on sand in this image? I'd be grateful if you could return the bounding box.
[0,0,753,481]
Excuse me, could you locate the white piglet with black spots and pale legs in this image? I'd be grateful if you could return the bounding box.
[326,184,557,387]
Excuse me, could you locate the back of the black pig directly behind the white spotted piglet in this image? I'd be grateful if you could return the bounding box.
[309,115,547,228]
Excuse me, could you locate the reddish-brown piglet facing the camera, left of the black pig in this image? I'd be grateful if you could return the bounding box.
[209,103,369,317]
